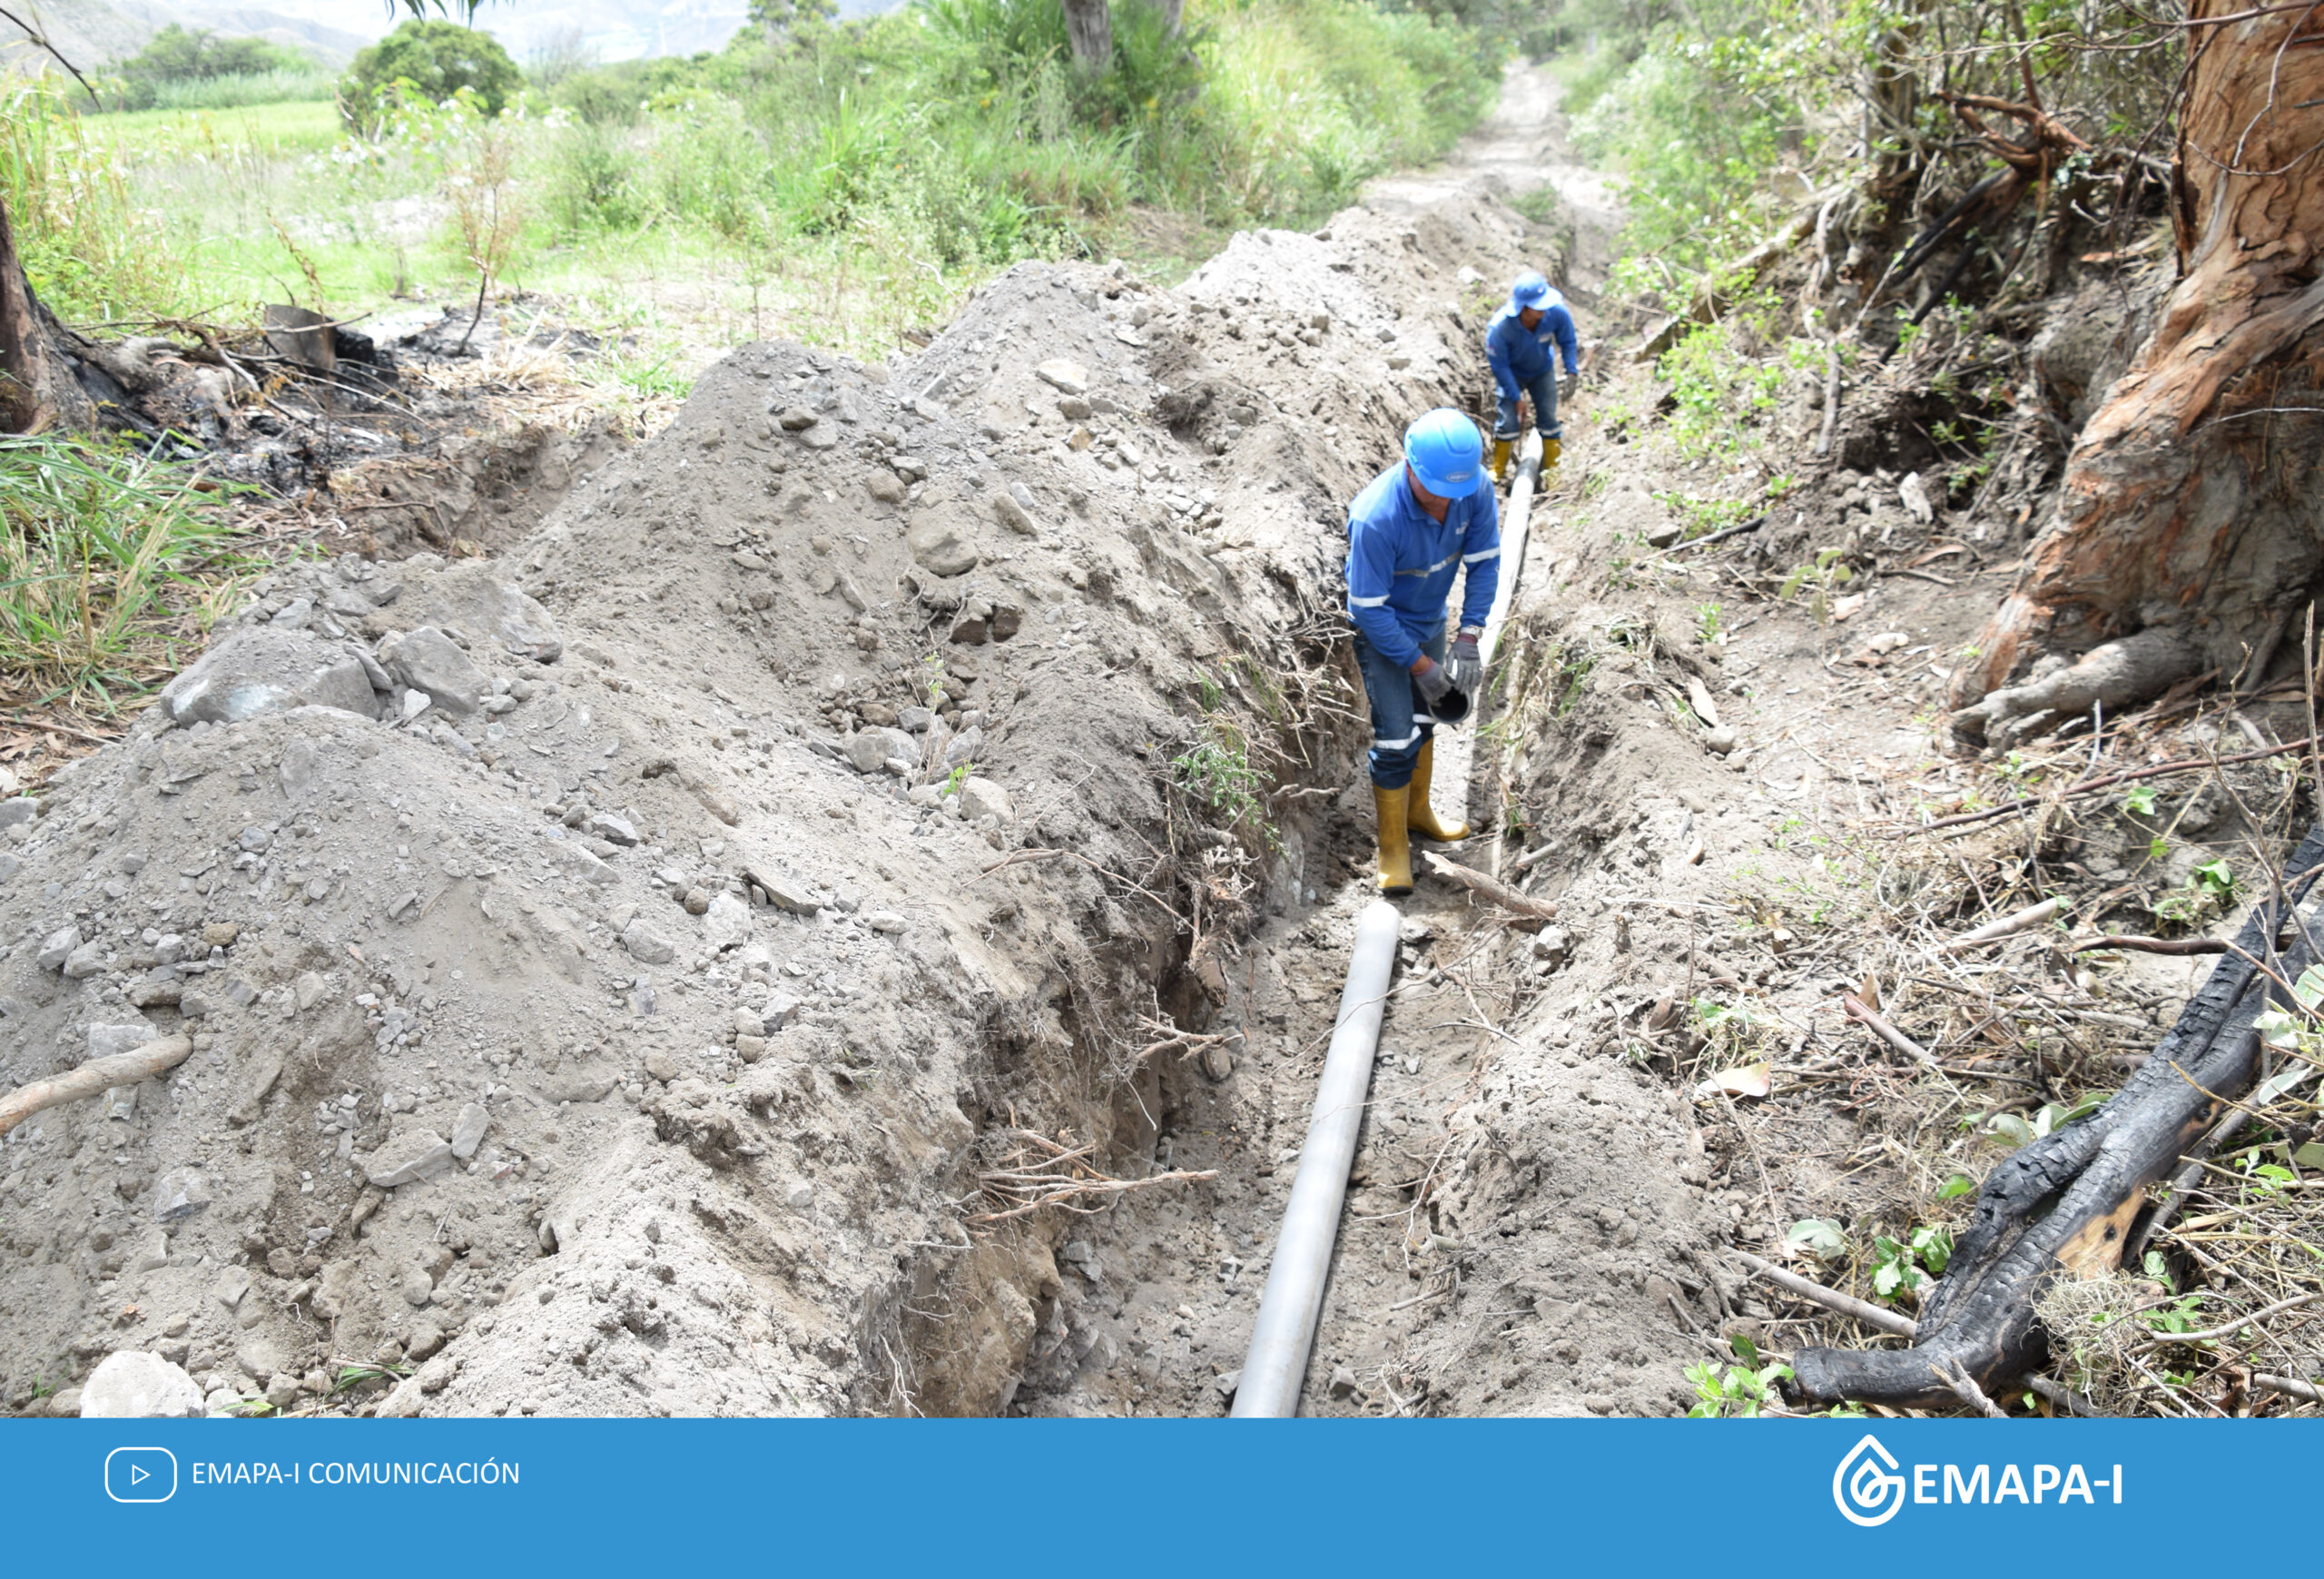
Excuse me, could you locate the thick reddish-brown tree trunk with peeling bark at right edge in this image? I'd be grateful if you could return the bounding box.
[1952,0,2324,745]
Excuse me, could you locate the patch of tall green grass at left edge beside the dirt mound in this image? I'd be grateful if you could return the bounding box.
[0,439,250,712]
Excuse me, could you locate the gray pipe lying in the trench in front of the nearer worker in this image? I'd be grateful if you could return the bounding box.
[1234,900,1402,1421]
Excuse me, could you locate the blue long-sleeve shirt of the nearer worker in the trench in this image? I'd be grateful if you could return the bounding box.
[1348,460,1502,667]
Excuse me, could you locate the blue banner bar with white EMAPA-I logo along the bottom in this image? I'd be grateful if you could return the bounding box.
[0,1421,2324,1579]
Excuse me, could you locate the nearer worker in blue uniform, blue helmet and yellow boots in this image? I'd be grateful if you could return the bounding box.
[1348,410,1502,893]
